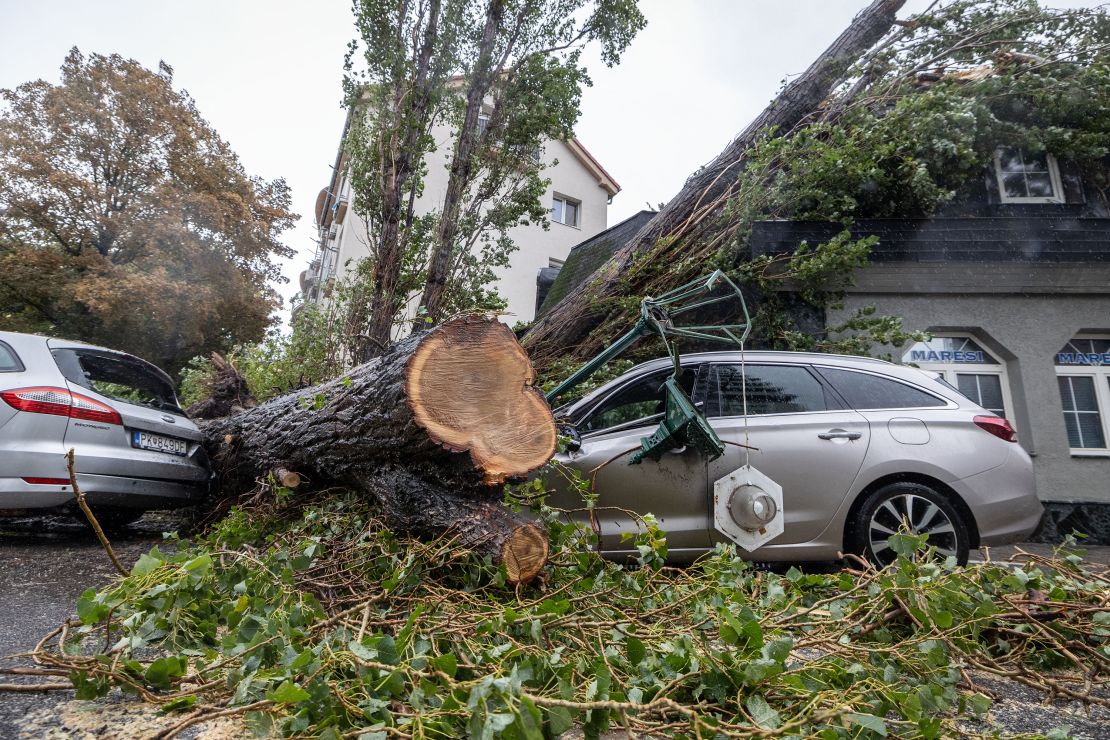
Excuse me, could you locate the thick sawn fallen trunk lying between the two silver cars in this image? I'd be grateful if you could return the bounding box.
[202,316,556,582]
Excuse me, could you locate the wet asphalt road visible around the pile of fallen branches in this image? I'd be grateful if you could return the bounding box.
[0,515,1110,739]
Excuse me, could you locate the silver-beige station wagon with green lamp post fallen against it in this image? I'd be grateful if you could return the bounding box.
[551,352,1042,562]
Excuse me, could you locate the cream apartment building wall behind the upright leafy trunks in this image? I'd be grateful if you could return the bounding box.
[313,126,609,324]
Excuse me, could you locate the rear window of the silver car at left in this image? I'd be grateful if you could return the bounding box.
[54,349,181,414]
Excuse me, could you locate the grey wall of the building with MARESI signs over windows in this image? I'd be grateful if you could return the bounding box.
[828,269,1110,503]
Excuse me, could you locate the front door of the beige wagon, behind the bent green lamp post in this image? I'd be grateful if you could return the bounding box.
[552,367,708,555]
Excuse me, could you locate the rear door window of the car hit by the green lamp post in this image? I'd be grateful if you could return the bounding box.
[708,365,839,417]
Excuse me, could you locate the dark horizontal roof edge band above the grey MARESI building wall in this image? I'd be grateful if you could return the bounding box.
[749,215,1110,262]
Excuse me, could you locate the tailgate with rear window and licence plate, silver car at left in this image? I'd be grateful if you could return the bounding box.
[52,346,208,484]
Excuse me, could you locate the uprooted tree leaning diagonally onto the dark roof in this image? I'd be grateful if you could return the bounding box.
[523,0,1110,375]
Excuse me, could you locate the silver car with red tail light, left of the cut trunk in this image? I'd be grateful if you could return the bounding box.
[0,332,210,526]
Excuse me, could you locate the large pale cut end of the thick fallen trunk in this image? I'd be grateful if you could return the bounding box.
[405,316,556,484]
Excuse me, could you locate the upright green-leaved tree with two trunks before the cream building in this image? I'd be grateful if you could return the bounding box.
[345,0,644,356]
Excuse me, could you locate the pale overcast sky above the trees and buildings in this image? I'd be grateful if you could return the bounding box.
[0,0,1096,319]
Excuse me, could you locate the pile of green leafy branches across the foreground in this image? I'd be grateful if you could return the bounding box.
[4,487,1110,738]
